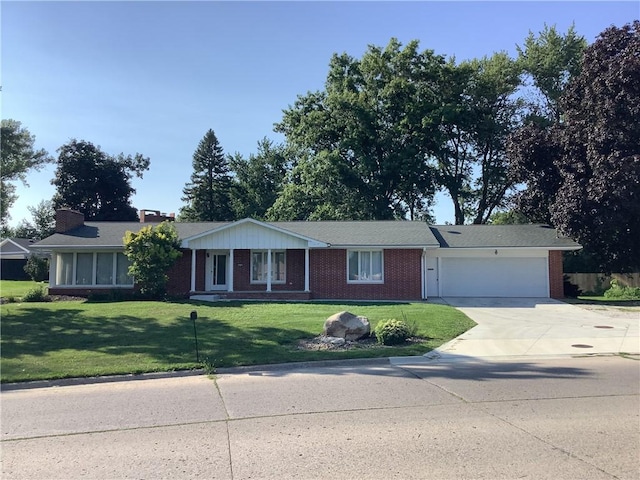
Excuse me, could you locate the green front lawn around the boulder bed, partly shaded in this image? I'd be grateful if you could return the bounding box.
[0,301,475,382]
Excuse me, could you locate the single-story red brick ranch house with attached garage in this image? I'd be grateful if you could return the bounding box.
[33,209,581,300]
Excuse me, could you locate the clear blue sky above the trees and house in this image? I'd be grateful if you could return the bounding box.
[0,1,640,225]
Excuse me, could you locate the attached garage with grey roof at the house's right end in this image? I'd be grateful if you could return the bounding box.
[423,224,581,298]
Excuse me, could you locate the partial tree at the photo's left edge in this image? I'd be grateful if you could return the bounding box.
[0,119,52,228]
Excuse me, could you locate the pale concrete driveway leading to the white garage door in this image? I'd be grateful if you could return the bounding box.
[428,298,640,359]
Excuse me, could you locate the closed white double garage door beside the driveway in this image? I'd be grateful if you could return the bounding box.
[440,257,549,297]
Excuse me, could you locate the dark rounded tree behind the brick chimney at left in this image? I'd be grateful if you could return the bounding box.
[51,139,150,221]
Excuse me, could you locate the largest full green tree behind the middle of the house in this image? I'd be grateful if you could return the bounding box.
[272,39,444,219]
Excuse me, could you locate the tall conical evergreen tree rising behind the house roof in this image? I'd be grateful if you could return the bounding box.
[180,129,234,222]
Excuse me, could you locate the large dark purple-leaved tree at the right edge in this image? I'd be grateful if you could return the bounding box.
[510,21,640,272]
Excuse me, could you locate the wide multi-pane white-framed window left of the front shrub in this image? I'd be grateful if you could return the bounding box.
[56,252,133,287]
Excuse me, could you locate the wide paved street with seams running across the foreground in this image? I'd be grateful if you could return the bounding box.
[0,356,640,480]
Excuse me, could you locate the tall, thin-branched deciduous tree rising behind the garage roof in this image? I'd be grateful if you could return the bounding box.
[434,53,521,225]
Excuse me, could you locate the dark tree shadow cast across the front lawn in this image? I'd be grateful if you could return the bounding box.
[2,307,309,366]
